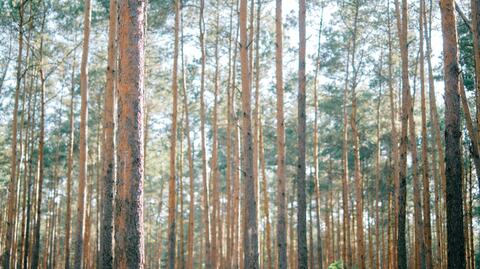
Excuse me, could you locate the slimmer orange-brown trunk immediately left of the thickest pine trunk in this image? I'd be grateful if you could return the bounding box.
[99,0,117,269]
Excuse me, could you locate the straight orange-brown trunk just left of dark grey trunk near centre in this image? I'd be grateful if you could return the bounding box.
[275,0,286,269]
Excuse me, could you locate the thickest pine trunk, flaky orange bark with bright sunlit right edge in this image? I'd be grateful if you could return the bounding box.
[114,1,145,264]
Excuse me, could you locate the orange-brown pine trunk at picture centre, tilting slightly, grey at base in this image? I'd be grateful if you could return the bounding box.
[240,0,258,268]
